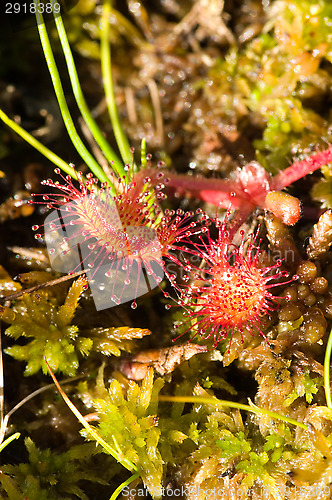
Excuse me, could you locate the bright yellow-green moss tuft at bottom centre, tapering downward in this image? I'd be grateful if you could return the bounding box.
[83,369,164,499]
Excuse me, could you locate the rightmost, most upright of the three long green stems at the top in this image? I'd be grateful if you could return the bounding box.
[100,0,132,163]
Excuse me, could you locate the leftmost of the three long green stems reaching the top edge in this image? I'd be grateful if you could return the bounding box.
[33,0,114,189]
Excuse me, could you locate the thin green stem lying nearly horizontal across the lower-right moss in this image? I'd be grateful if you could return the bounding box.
[159,396,307,429]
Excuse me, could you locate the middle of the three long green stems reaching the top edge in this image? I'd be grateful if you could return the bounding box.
[53,11,125,176]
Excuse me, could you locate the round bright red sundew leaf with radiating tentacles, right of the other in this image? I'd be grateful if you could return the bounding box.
[172,212,296,347]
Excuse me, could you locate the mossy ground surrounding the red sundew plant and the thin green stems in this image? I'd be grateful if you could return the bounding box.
[0,0,332,500]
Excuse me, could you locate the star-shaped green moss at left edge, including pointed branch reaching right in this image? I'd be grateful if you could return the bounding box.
[0,278,150,376]
